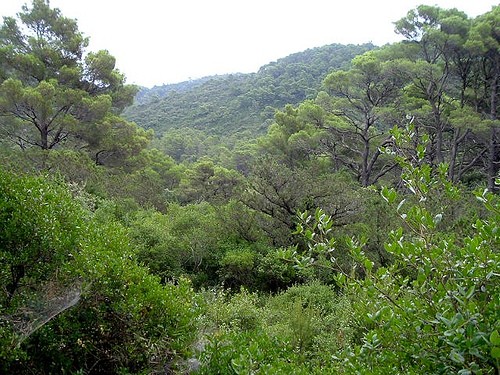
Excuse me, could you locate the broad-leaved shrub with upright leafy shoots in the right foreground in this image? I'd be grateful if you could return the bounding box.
[294,128,500,373]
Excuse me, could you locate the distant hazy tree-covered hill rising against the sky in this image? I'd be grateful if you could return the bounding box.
[124,44,375,136]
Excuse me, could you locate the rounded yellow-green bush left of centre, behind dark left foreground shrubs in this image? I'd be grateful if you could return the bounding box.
[129,202,230,286]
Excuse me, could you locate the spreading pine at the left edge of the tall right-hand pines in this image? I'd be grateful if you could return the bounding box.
[316,51,404,187]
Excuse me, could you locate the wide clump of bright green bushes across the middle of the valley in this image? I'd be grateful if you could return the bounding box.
[127,202,307,291]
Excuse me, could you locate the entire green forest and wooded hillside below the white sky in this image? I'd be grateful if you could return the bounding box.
[0,0,500,375]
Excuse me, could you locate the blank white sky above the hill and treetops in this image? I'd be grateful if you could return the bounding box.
[0,0,498,87]
